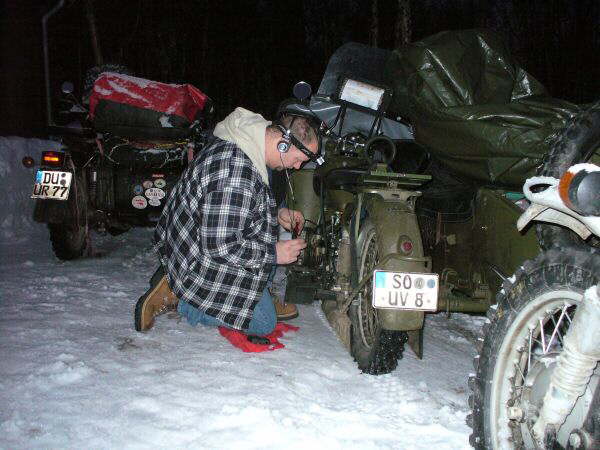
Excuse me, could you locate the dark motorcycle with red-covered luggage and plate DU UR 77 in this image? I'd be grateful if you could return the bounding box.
[23,70,213,260]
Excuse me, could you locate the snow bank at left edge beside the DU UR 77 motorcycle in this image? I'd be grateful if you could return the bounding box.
[0,136,60,242]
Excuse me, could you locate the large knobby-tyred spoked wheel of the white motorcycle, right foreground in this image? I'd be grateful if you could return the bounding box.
[467,249,600,449]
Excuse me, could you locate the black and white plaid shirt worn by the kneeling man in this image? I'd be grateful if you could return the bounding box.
[154,137,277,330]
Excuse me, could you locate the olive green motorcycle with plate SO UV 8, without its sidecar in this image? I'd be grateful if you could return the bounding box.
[280,78,439,374]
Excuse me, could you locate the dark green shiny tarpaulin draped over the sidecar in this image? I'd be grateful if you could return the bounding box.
[385,30,580,189]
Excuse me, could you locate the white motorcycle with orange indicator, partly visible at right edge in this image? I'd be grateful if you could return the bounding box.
[467,164,600,449]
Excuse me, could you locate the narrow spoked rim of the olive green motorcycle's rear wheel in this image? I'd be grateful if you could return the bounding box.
[358,231,379,349]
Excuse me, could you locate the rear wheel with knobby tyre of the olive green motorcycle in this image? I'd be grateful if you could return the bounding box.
[349,221,408,375]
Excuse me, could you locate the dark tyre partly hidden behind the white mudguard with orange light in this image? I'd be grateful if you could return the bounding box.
[536,101,600,253]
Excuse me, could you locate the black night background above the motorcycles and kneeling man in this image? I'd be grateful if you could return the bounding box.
[0,0,600,137]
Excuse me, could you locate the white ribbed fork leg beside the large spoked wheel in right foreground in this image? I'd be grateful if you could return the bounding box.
[533,285,600,448]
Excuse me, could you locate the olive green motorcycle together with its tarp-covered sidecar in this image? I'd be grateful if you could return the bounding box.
[283,30,597,374]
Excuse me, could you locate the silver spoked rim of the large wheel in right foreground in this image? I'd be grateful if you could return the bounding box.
[489,291,599,448]
